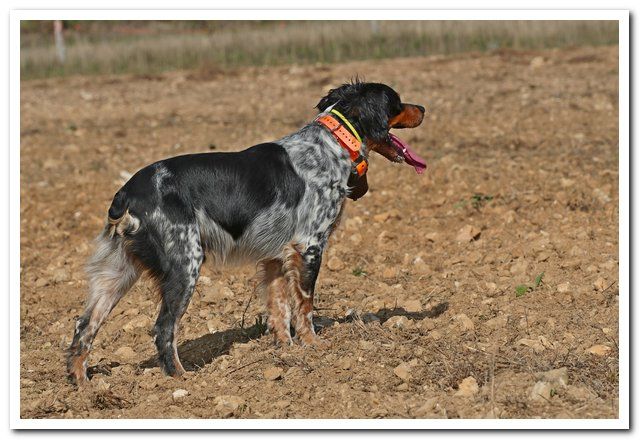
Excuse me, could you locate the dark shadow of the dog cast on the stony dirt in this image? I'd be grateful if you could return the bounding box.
[89,302,449,374]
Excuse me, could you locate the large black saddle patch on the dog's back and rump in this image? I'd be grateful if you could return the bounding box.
[109,143,305,241]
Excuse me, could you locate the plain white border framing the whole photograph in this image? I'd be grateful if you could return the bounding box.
[9,9,631,429]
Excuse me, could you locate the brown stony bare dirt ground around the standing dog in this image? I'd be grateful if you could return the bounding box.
[20,47,619,418]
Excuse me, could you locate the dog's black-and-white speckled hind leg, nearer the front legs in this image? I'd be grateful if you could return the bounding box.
[153,225,204,377]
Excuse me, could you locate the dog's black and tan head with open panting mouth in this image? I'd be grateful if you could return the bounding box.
[316,80,425,165]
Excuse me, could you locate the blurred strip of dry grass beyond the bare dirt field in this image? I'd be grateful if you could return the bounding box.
[20,21,618,79]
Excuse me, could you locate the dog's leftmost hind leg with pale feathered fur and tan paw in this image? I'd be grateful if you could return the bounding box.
[67,230,140,384]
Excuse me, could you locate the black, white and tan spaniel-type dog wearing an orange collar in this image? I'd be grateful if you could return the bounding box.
[67,80,426,384]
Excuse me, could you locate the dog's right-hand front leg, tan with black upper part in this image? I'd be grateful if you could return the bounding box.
[283,244,327,345]
